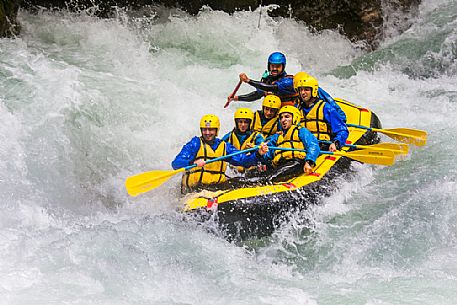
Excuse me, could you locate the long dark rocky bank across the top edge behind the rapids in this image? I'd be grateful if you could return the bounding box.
[18,0,420,48]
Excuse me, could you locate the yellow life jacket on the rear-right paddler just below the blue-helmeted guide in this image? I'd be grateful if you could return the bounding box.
[301,100,332,141]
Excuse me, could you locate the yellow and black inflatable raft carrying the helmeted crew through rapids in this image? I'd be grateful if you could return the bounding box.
[183,99,382,239]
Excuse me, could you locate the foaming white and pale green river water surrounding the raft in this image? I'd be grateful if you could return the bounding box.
[0,0,457,305]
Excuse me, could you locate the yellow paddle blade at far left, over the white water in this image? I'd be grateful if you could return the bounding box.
[125,168,184,196]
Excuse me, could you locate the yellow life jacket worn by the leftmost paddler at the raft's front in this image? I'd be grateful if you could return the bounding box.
[182,138,227,189]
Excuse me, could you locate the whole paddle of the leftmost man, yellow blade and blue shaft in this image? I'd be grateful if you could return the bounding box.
[125,145,260,196]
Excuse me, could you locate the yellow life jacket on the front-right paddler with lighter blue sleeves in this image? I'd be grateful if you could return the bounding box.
[272,125,306,167]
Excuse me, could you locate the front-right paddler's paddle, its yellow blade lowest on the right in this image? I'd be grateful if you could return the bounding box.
[268,146,395,165]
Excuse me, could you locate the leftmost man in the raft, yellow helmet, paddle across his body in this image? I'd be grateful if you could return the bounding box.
[171,114,268,193]
